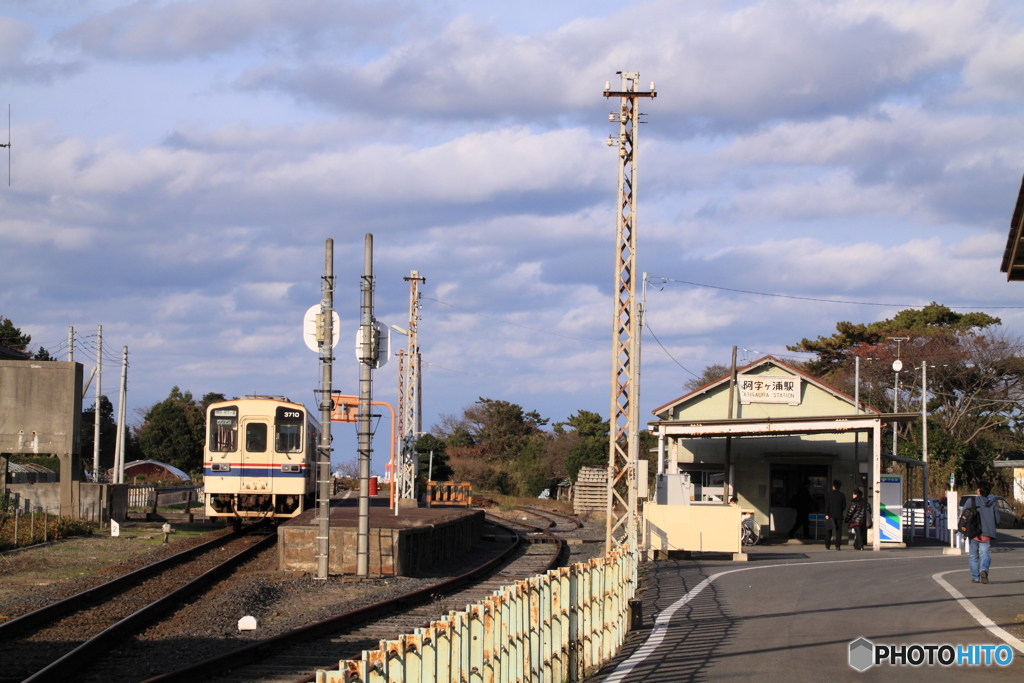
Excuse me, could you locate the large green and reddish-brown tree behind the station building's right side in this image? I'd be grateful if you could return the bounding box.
[788,302,1024,480]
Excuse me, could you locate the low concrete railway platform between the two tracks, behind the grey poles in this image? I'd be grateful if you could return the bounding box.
[278,497,484,577]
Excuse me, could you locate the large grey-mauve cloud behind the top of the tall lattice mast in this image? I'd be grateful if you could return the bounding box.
[232,0,1007,134]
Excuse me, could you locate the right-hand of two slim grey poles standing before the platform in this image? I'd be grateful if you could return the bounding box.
[355,232,378,577]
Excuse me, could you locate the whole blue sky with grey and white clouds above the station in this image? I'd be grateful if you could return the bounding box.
[0,0,1024,469]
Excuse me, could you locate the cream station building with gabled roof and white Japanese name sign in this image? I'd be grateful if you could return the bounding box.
[648,356,915,533]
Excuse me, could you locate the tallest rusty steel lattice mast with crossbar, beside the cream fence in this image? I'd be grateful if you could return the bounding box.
[604,72,657,552]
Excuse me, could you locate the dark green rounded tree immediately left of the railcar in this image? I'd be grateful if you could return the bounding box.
[138,387,209,473]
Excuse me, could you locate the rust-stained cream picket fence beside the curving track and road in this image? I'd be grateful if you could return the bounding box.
[316,550,636,683]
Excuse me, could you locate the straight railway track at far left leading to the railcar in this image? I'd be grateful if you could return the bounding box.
[0,527,275,683]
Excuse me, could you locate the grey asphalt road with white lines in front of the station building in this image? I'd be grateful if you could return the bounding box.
[592,531,1024,683]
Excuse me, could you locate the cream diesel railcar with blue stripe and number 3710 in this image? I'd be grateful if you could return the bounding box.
[203,396,319,520]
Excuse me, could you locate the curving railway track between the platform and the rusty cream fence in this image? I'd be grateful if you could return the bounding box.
[137,520,563,683]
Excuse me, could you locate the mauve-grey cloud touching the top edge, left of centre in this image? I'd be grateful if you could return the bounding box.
[55,0,418,60]
